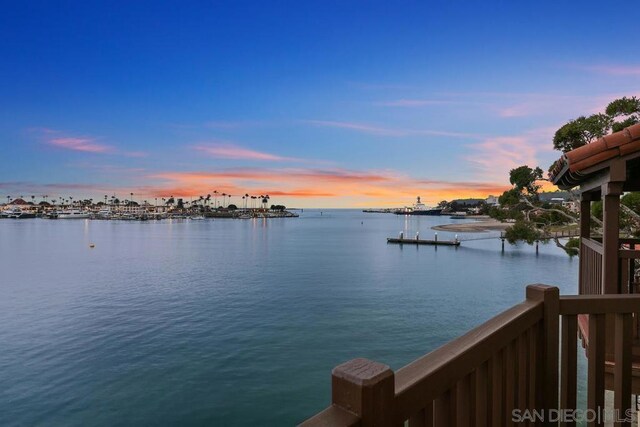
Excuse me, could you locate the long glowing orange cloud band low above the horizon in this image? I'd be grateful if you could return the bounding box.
[138,168,509,206]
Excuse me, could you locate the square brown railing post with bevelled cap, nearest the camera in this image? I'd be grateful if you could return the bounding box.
[331,358,395,427]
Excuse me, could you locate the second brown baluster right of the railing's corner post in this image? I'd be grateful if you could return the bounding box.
[587,314,606,426]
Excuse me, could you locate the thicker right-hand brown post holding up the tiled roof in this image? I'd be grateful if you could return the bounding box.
[602,182,622,294]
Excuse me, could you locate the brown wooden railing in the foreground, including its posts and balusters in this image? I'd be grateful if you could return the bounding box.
[302,285,640,427]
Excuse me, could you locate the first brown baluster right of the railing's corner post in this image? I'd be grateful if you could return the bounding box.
[560,315,578,426]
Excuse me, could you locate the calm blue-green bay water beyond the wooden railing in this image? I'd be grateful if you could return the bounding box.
[0,210,578,426]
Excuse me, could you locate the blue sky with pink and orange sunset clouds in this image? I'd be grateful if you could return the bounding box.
[0,0,640,208]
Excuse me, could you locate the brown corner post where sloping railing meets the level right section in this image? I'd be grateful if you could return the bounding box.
[527,285,560,425]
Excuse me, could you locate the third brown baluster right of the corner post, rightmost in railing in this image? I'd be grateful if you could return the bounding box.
[613,313,633,426]
